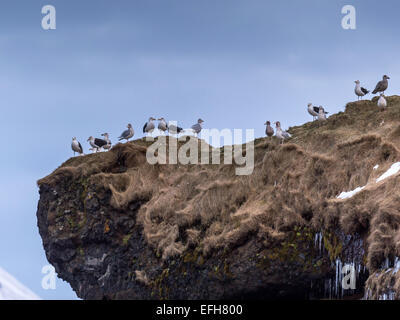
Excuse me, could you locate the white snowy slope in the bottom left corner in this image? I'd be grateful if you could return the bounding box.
[0,267,40,300]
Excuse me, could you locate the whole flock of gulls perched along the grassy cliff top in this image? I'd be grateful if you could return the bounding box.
[71,75,390,156]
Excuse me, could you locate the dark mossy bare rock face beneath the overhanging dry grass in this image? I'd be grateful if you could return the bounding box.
[37,178,363,299]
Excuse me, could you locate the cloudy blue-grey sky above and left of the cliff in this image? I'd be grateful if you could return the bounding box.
[0,0,400,299]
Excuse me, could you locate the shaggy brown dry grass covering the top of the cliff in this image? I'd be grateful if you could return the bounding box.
[38,96,400,298]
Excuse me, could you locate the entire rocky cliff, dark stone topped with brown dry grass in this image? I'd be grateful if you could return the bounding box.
[37,96,400,299]
